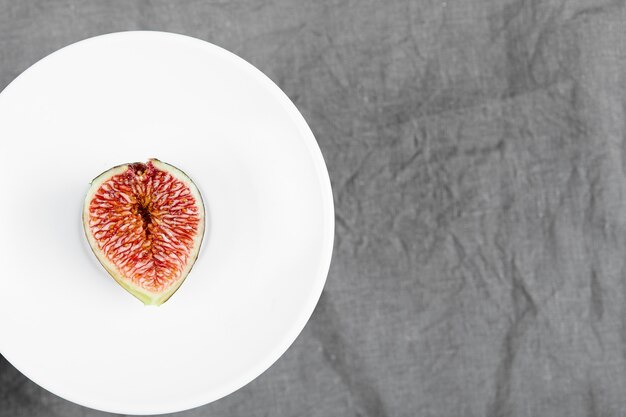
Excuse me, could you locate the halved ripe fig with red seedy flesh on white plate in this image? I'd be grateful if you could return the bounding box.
[83,159,205,305]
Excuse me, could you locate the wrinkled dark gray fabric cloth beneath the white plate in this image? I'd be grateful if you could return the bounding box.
[0,0,626,417]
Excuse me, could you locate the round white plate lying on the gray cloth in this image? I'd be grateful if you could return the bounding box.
[0,32,334,414]
